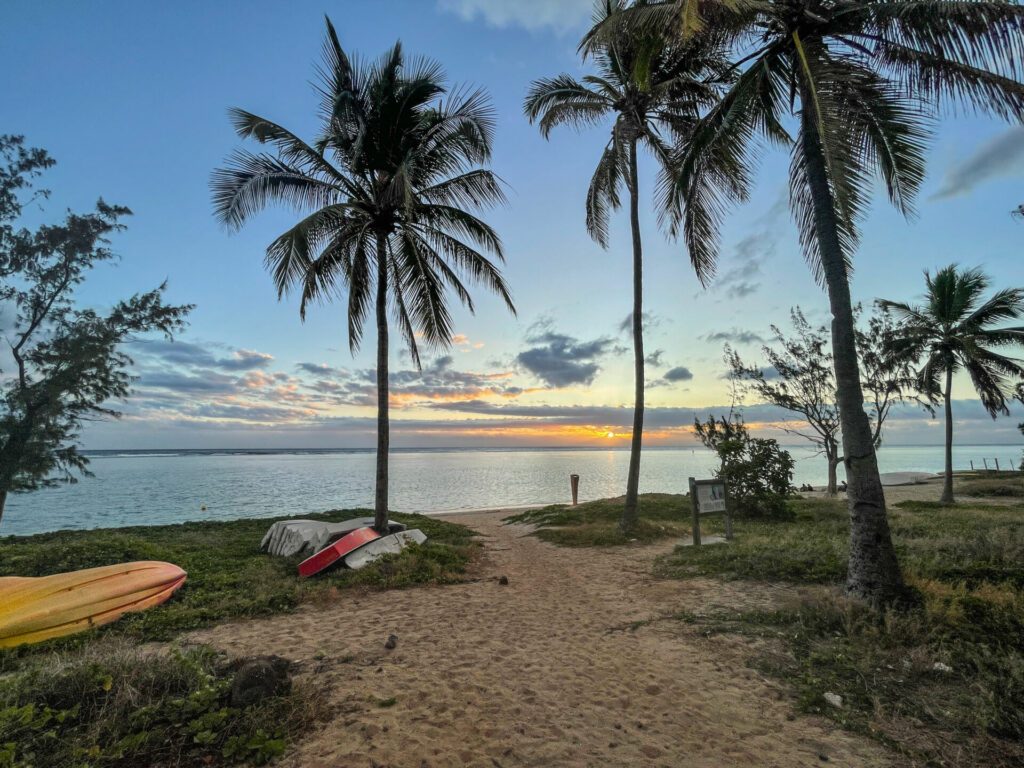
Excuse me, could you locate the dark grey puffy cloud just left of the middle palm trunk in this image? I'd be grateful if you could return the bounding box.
[516,318,615,388]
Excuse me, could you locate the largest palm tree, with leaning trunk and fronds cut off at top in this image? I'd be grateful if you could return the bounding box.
[589,0,1024,604]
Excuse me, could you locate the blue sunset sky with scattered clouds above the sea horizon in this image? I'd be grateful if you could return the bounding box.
[0,0,1024,449]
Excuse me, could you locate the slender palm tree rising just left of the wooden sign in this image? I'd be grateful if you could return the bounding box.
[524,0,723,531]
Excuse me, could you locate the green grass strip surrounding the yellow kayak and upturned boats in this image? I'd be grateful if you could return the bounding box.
[0,510,478,655]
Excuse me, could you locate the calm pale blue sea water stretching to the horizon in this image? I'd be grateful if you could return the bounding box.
[0,445,1021,536]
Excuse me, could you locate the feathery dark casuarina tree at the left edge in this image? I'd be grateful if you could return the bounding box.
[0,135,191,518]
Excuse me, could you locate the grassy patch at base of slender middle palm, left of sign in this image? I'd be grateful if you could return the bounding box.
[505,494,705,547]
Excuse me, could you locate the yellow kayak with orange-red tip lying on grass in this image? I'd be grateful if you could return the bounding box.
[0,561,186,648]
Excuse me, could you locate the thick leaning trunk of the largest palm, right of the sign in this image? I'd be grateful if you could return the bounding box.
[801,99,903,606]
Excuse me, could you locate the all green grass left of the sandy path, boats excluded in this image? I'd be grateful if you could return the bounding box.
[0,510,479,768]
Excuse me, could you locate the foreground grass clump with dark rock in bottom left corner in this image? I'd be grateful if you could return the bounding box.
[0,638,330,768]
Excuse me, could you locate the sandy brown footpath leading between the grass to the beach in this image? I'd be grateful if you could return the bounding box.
[194,513,891,768]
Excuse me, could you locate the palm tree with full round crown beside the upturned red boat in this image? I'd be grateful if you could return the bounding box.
[212,19,515,532]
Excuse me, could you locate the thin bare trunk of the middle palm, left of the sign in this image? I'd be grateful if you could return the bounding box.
[620,137,644,532]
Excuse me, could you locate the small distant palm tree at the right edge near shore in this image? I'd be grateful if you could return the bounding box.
[879,264,1024,504]
